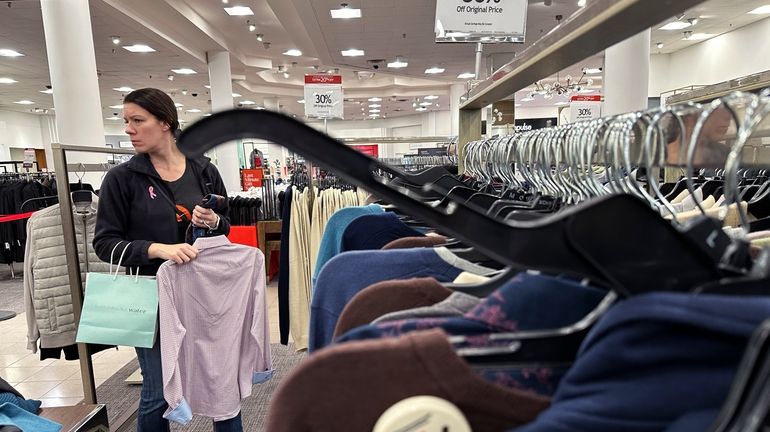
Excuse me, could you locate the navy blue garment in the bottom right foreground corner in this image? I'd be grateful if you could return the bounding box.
[516,292,770,432]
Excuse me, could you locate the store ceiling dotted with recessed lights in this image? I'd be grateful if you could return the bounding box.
[0,0,765,122]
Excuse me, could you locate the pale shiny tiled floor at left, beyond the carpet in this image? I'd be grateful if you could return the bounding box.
[0,283,280,406]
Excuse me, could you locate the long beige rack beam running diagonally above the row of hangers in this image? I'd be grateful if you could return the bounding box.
[459,0,704,172]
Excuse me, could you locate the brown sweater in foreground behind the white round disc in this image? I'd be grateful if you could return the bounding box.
[266,330,550,432]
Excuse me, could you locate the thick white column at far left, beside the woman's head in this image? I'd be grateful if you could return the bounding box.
[40,0,106,189]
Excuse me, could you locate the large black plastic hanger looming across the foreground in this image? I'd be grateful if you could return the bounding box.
[177,109,744,295]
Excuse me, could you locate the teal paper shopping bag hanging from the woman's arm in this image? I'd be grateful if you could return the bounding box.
[75,242,158,348]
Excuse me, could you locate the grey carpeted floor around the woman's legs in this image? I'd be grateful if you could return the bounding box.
[114,344,305,432]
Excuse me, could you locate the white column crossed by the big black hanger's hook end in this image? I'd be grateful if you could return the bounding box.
[206,51,241,192]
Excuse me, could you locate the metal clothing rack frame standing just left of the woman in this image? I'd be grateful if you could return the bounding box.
[51,143,138,411]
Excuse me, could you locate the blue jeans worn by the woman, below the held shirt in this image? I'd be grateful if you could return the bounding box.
[136,338,243,432]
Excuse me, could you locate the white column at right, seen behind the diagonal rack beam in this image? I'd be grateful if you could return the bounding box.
[602,29,650,115]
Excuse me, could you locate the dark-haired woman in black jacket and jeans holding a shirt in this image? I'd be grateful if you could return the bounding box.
[94,88,234,432]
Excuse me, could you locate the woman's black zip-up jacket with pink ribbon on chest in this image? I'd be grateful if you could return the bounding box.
[93,154,230,276]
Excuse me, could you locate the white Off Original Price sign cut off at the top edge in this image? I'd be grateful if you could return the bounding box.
[435,0,528,43]
